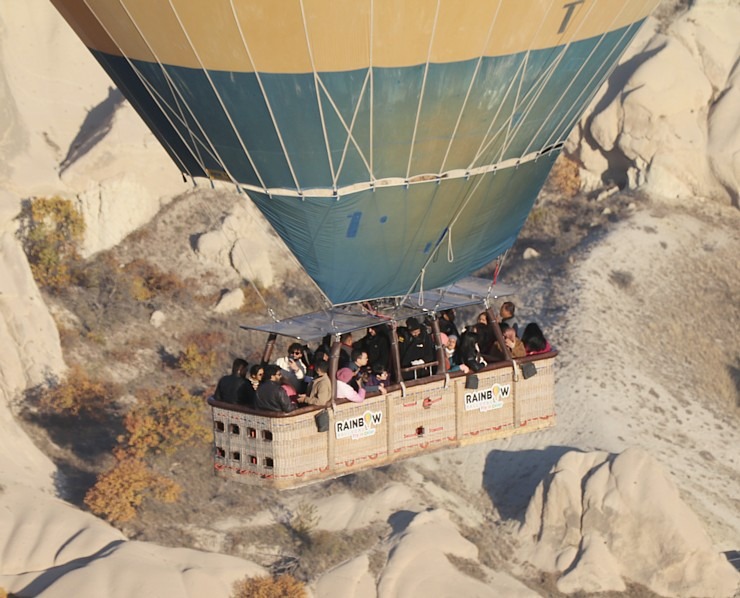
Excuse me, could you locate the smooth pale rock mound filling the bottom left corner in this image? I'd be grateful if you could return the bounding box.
[0,489,265,598]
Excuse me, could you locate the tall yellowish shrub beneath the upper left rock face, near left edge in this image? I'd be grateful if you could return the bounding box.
[19,197,85,291]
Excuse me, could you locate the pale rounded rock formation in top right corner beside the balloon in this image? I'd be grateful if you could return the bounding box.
[566,1,740,206]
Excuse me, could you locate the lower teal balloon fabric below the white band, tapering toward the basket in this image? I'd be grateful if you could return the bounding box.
[250,153,555,304]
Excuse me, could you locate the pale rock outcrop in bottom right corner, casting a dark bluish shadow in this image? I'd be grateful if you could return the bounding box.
[520,448,740,598]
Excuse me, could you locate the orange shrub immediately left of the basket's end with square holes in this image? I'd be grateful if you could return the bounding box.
[119,385,211,458]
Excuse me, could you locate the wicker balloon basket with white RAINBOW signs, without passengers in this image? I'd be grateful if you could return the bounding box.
[212,354,555,489]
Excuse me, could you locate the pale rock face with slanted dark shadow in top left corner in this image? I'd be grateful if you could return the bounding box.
[0,0,189,255]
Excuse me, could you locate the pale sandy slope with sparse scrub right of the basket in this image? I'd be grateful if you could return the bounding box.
[422,197,740,550]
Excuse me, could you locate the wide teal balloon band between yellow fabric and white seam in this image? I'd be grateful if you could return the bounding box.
[97,23,640,190]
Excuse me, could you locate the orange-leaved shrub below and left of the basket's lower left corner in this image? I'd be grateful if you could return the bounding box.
[85,457,181,523]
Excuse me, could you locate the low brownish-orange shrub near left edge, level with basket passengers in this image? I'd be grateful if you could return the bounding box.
[39,365,115,417]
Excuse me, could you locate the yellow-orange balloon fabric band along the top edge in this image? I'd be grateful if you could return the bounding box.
[52,0,659,73]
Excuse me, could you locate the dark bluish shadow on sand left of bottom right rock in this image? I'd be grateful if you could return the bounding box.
[483,446,580,522]
